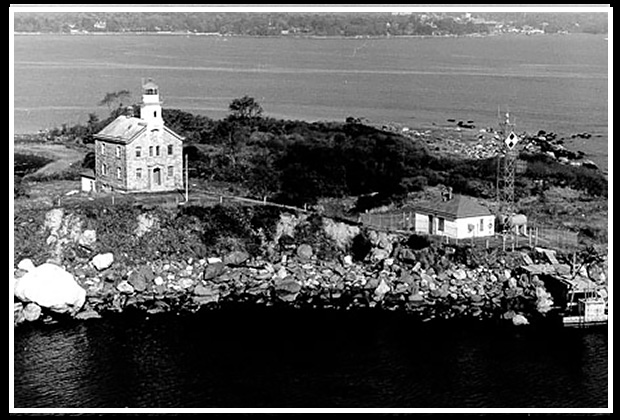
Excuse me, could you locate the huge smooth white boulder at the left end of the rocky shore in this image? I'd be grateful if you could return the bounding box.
[14,263,86,313]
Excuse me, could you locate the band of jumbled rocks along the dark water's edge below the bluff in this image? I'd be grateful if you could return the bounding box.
[8,233,572,325]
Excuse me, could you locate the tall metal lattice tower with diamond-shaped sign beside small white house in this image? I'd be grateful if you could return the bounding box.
[497,112,519,218]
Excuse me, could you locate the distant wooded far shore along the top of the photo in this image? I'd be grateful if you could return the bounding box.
[14,12,607,36]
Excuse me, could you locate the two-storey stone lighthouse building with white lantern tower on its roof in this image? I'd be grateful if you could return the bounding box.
[94,79,183,192]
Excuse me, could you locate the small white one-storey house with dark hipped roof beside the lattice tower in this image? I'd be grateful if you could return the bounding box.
[413,192,495,239]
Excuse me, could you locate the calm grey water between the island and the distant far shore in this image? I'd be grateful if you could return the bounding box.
[14,34,608,167]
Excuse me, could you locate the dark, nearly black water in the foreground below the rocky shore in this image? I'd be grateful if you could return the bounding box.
[14,308,608,408]
